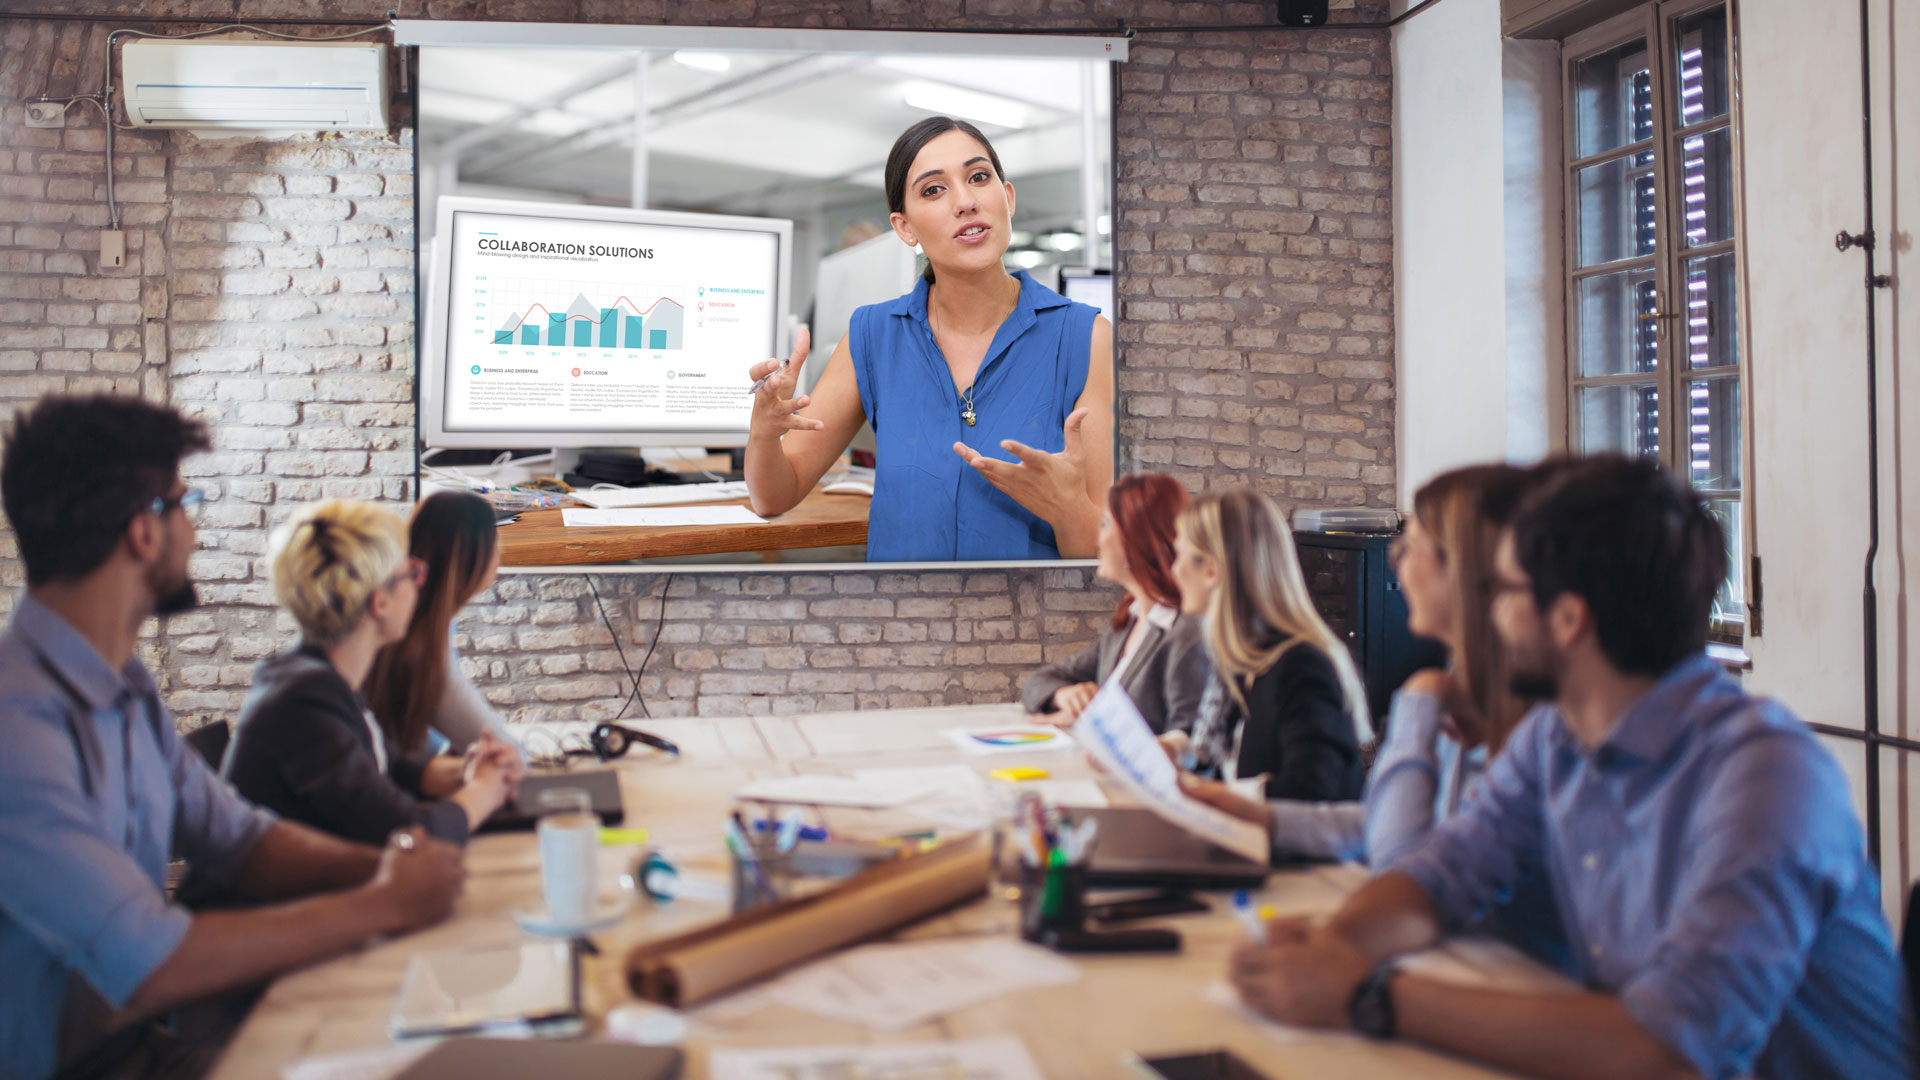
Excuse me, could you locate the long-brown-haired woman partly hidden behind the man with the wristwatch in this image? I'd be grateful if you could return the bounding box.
[1187,463,1559,869]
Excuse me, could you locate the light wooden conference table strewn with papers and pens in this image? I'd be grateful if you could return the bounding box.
[213,705,1569,1080]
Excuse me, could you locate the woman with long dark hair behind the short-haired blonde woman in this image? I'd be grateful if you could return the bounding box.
[367,492,518,755]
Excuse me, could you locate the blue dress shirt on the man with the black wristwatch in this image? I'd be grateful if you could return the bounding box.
[1398,655,1914,1080]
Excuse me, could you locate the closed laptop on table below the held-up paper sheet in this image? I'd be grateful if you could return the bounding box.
[1064,807,1269,890]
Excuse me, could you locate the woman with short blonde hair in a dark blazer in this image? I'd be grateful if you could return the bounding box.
[223,500,520,844]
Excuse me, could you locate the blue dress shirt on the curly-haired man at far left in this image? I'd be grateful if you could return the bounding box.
[0,594,275,1080]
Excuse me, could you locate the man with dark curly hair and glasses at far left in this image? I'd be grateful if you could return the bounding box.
[0,398,463,1080]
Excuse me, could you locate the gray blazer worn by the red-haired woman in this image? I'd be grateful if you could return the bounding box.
[1021,613,1213,734]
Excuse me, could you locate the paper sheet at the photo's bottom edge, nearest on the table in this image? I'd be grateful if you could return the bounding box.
[707,1036,1043,1080]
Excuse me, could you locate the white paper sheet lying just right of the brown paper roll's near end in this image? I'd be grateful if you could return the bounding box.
[744,938,1079,1032]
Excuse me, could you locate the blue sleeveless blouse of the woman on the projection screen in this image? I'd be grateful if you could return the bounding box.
[847,271,1100,563]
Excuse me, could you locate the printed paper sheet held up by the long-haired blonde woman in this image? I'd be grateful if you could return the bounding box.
[1073,678,1267,863]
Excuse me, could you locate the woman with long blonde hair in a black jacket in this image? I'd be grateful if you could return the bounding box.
[1173,488,1373,799]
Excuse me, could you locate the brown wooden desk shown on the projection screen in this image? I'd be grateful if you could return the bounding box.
[499,478,874,567]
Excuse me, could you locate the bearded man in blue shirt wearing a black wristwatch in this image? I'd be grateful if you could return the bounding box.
[1233,457,1914,1080]
